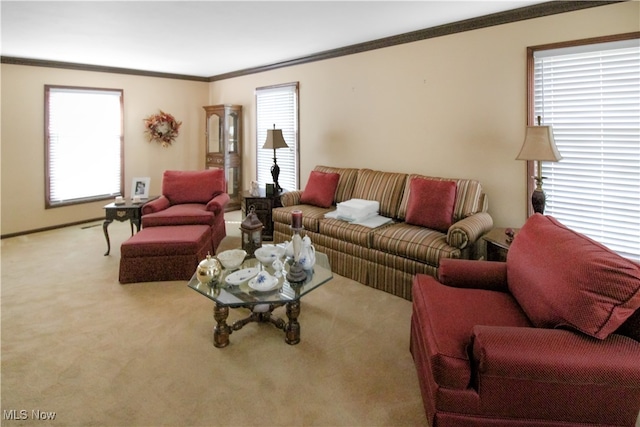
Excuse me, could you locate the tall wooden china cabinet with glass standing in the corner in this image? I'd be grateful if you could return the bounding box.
[202,104,242,211]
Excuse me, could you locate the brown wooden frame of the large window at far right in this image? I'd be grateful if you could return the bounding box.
[526,32,640,260]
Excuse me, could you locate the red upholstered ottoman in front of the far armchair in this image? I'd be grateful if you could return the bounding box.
[120,225,214,283]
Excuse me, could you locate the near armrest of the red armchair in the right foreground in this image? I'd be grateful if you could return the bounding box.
[471,325,640,425]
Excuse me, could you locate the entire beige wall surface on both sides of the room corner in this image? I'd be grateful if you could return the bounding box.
[2,1,640,234]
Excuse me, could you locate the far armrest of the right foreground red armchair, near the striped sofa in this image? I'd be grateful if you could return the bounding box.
[438,258,509,292]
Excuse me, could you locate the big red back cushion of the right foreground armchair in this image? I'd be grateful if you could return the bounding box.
[507,214,640,339]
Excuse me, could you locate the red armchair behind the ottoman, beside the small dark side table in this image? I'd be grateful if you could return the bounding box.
[142,169,229,251]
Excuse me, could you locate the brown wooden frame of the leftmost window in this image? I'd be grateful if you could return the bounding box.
[44,85,124,209]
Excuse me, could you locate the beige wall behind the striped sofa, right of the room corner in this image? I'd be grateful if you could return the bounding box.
[211,2,640,227]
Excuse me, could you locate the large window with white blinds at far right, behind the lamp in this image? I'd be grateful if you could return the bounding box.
[530,34,640,260]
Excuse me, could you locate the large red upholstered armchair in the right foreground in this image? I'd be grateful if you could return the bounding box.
[410,214,640,427]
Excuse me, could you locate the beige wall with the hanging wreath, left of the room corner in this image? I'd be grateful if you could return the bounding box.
[1,64,209,235]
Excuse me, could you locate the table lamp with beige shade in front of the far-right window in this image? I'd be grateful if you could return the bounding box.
[516,116,562,214]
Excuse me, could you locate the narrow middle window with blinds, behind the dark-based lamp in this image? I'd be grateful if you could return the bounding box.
[256,82,299,190]
